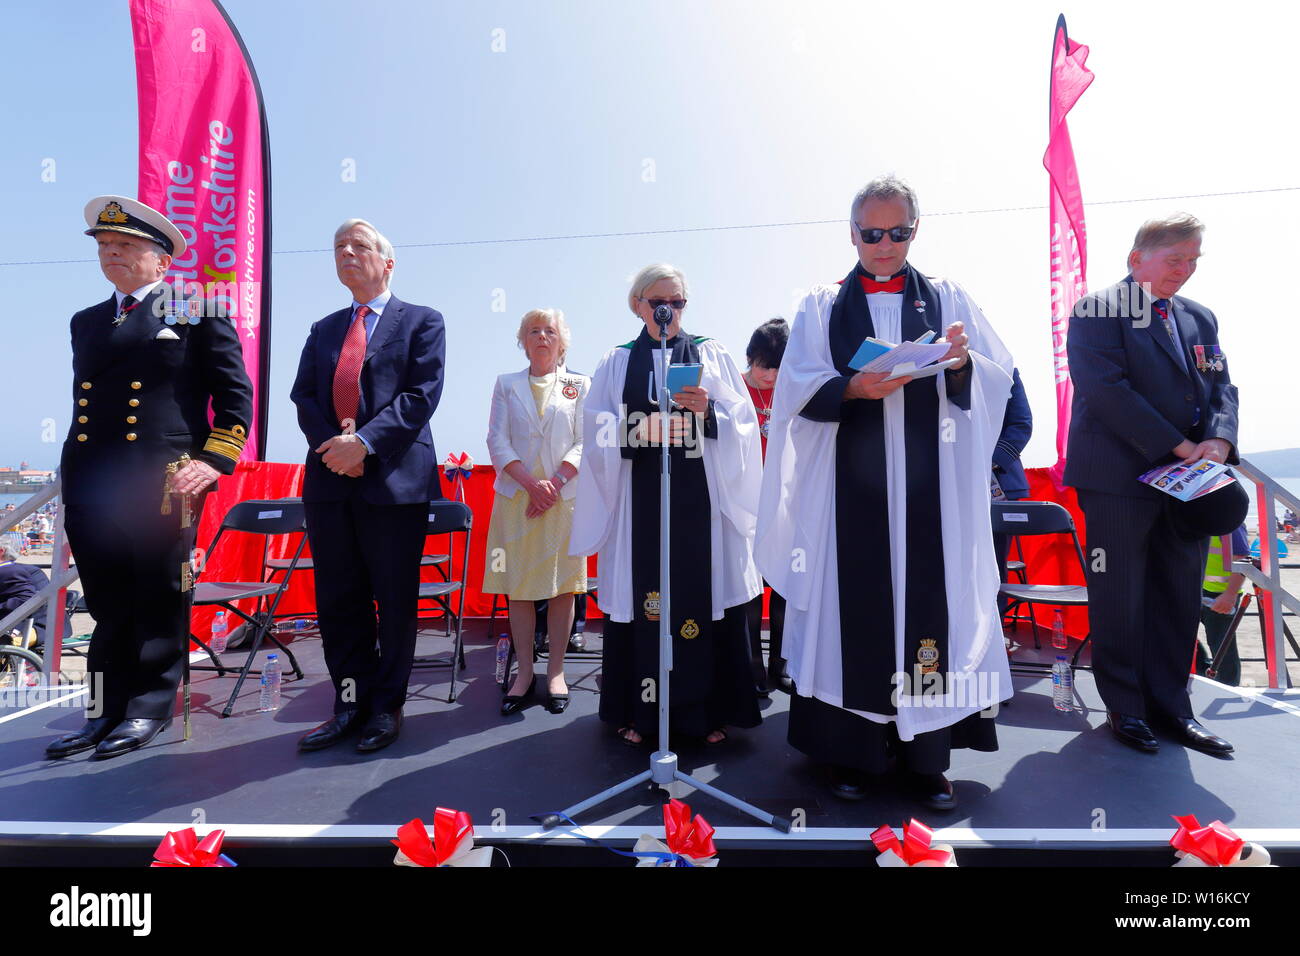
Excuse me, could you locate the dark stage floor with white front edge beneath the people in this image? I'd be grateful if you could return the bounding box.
[0,622,1300,866]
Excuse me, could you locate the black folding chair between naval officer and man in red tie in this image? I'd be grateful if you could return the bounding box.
[185,498,307,726]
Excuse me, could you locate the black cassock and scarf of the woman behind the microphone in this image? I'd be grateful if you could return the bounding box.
[601,330,761,741]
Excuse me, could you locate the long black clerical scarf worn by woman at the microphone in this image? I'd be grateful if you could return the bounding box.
[623,329,715,712]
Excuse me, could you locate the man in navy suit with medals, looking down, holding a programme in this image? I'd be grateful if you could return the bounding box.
[1065,213,1238,757]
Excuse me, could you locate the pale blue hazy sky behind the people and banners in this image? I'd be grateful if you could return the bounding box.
[0,0,1300,467]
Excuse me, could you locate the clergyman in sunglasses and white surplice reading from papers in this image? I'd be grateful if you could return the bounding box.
[755,176,1013,810]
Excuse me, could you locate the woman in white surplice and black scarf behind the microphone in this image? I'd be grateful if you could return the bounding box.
[569,264,762,744]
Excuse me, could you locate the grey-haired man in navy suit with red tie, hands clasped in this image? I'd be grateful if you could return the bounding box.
[290,219,445,753]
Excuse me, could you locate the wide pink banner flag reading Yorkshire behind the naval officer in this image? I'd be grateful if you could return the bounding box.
[130,0,270,460]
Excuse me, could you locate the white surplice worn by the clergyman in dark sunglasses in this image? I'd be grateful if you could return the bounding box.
[755,280,1011,740]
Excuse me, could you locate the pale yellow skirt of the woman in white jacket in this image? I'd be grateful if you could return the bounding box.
[482,468,586,601]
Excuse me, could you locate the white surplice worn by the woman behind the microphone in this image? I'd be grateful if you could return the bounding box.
[569,333,763,622]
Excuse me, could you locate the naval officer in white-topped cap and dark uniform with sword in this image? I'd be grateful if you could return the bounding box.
[46,196,252,757]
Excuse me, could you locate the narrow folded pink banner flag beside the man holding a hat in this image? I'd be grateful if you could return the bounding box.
[1043,16,1092,489]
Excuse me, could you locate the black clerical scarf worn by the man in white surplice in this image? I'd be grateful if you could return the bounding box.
[829,264,952,714]
